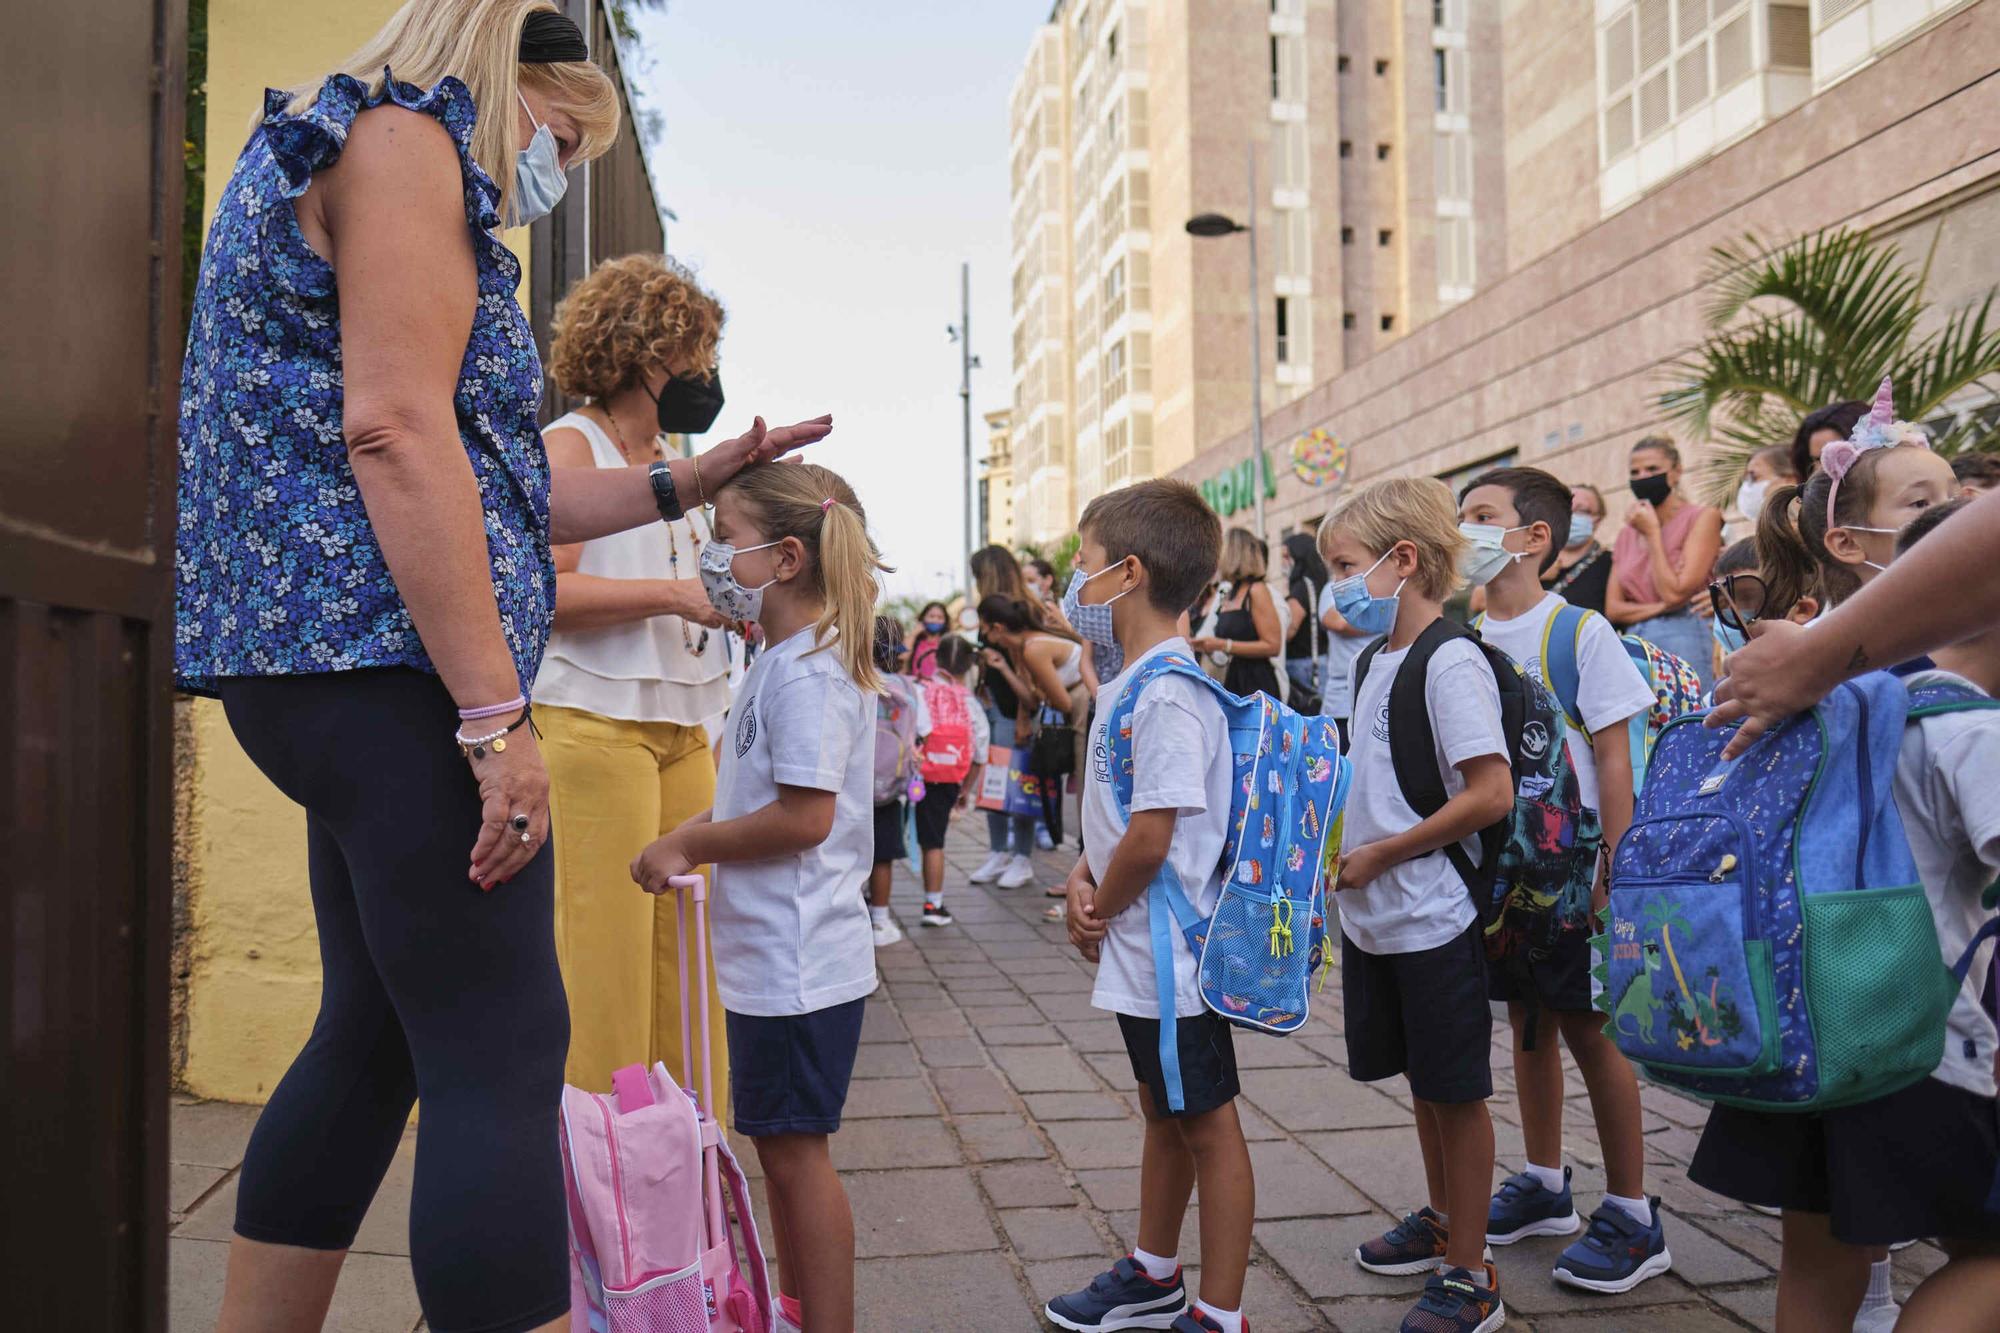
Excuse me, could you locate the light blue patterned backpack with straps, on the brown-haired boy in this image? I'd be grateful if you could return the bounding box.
[1104,652,1354,1111]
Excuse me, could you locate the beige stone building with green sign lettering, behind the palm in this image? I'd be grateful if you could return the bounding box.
[1180,0,2000,534]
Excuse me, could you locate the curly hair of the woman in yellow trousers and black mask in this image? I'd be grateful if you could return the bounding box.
[548,254,724,402]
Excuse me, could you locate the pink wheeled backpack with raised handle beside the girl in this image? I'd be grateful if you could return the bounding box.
[562,875,774,1333]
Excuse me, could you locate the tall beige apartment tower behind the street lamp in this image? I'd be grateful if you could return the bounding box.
[1010,0,1508,540]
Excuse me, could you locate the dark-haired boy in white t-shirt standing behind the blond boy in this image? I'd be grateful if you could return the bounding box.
[1458,468,1672,1291]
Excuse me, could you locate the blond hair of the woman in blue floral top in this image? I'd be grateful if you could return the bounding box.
[274,0,618,218]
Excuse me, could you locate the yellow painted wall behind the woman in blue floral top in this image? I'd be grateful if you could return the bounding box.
[176,0,528,1101]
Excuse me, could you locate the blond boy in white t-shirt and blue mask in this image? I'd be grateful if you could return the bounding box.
[1320,476,1514,1329]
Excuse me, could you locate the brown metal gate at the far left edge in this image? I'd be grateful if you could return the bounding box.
[0,0,186,1331]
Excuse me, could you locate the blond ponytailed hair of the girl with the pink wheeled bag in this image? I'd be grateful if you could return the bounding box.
[722,462,888,693]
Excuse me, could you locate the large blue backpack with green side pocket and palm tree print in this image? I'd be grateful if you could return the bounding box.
[1592,673,2000,1111]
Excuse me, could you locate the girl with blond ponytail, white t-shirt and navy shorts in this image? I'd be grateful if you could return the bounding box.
[632,464,886,1333]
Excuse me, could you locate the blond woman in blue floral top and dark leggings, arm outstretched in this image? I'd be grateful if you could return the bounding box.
[176,0,830,1333]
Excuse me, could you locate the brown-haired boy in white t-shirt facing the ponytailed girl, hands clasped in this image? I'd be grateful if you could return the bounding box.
[1044,480,1256,1333]
